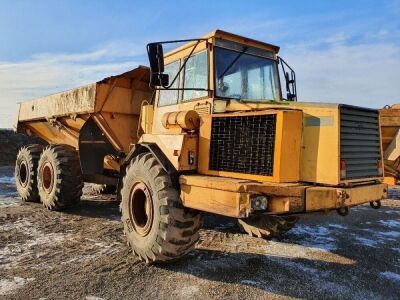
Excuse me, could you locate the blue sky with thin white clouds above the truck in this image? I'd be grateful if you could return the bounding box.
[0,0,400,128]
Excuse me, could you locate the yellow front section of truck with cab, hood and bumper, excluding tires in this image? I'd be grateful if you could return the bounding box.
[142,30,386,217]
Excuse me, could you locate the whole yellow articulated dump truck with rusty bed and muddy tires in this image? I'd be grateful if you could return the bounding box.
[15,30,387,262]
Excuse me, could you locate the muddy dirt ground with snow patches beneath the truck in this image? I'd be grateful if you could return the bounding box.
[0,167,400,300]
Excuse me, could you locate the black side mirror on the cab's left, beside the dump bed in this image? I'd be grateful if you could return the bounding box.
[147,43,169,87]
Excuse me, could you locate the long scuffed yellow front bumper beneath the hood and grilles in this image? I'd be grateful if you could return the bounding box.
[179,175,387,218]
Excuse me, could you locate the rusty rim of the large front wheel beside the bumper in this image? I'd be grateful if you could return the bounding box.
[129,182,153,236]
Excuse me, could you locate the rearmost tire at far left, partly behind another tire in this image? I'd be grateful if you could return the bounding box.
[15,145,43,202]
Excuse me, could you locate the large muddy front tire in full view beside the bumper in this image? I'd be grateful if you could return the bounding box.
[121,153,201,263]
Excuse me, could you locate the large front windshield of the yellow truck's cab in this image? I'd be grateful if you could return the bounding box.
[214,47,280,101]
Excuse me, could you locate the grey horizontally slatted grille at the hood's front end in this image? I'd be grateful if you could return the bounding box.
[340,105,381,179]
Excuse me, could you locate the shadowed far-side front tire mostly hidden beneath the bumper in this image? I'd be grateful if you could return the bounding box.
[238,216,298,239]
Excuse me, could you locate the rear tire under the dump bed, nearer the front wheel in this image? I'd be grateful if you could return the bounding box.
[38,145,83,210]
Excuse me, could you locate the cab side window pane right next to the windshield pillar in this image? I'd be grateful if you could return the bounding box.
[183,51,208,101]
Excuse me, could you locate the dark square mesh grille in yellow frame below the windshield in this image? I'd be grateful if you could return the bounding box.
[209,114,276,176]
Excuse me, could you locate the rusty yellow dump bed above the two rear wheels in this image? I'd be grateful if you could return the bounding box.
[15,66,152,153]
